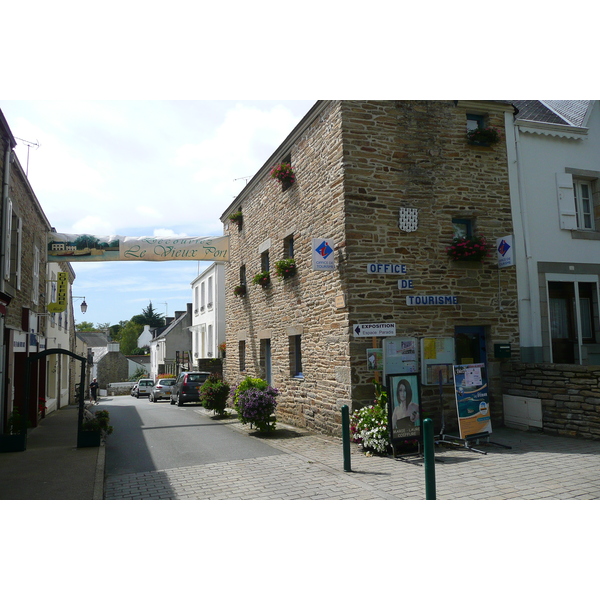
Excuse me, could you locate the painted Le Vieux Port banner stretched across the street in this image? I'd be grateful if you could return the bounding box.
[48,232,229,262]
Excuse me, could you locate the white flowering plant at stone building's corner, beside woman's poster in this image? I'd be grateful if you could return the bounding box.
[350,382,390,454]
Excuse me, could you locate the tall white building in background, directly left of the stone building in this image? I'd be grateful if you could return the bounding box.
[190,263,225,361]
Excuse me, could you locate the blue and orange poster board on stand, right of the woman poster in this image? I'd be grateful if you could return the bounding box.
[453,363,492,439]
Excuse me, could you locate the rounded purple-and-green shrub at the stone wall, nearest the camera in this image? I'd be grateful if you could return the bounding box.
[233,377,279,433]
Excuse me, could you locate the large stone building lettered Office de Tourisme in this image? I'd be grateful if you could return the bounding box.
[221,101,519,435]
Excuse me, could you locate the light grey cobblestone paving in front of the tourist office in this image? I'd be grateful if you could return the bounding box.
[105,420,600,500]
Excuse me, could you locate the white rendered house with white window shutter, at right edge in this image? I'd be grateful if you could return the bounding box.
[507,100,600,365]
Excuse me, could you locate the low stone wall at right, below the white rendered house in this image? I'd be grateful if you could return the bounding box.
[503,363,600,439]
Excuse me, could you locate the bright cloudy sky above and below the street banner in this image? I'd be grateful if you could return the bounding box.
[0,100,315,325]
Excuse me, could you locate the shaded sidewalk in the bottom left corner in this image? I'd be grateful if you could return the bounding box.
[0,406,105,500]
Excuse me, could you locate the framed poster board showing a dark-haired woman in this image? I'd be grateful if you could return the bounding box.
[387,373,421,441]
